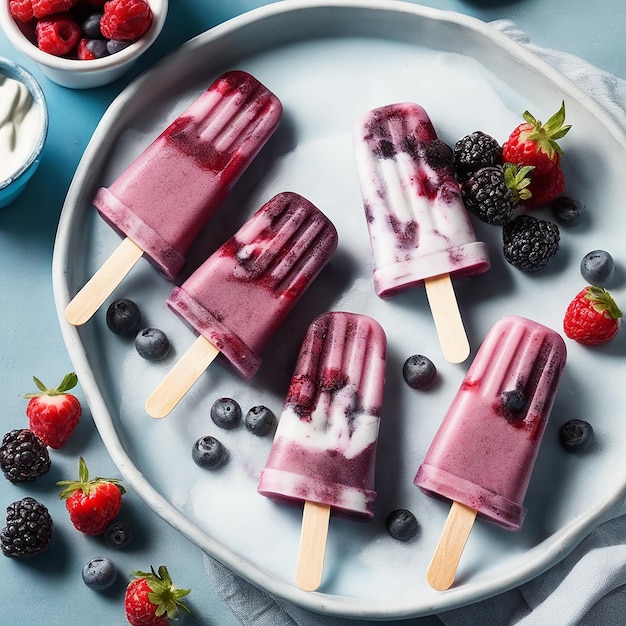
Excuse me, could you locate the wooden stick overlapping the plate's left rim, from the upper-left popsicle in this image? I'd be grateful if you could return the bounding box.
[65,237,143,326]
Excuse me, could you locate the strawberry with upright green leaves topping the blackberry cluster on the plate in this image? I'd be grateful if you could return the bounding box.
[502,102,571,173]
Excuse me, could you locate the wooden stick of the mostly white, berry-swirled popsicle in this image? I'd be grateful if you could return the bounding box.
[424,274,470,363]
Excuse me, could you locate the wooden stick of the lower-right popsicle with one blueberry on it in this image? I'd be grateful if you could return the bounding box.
[426,502,478,591]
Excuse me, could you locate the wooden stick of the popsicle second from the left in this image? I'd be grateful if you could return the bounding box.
[146,335,220,418]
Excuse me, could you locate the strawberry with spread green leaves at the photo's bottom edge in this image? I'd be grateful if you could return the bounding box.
[124,565,191,626]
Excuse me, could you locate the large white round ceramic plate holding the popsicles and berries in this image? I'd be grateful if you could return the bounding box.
[54,0,626,619]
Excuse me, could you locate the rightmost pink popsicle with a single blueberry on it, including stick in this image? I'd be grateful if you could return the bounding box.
[415,316,566,590]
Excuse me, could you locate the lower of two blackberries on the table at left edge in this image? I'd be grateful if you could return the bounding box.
[0,497,52,558]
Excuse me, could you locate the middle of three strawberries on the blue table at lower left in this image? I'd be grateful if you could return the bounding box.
[57,457,126,535]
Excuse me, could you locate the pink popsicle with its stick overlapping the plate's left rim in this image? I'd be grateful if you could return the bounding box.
[65,70,282,326]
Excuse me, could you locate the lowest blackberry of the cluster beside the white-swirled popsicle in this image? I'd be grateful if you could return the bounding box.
[502,215,560,272]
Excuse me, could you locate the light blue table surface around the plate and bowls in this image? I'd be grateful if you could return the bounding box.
[0,0,626,626]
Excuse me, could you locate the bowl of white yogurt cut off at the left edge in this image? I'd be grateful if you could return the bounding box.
[0,58,48,207]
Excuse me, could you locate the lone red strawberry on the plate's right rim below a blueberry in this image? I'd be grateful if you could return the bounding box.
[563,285,622,346]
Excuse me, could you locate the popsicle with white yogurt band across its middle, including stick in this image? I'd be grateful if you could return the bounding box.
[258,312,387,591]
